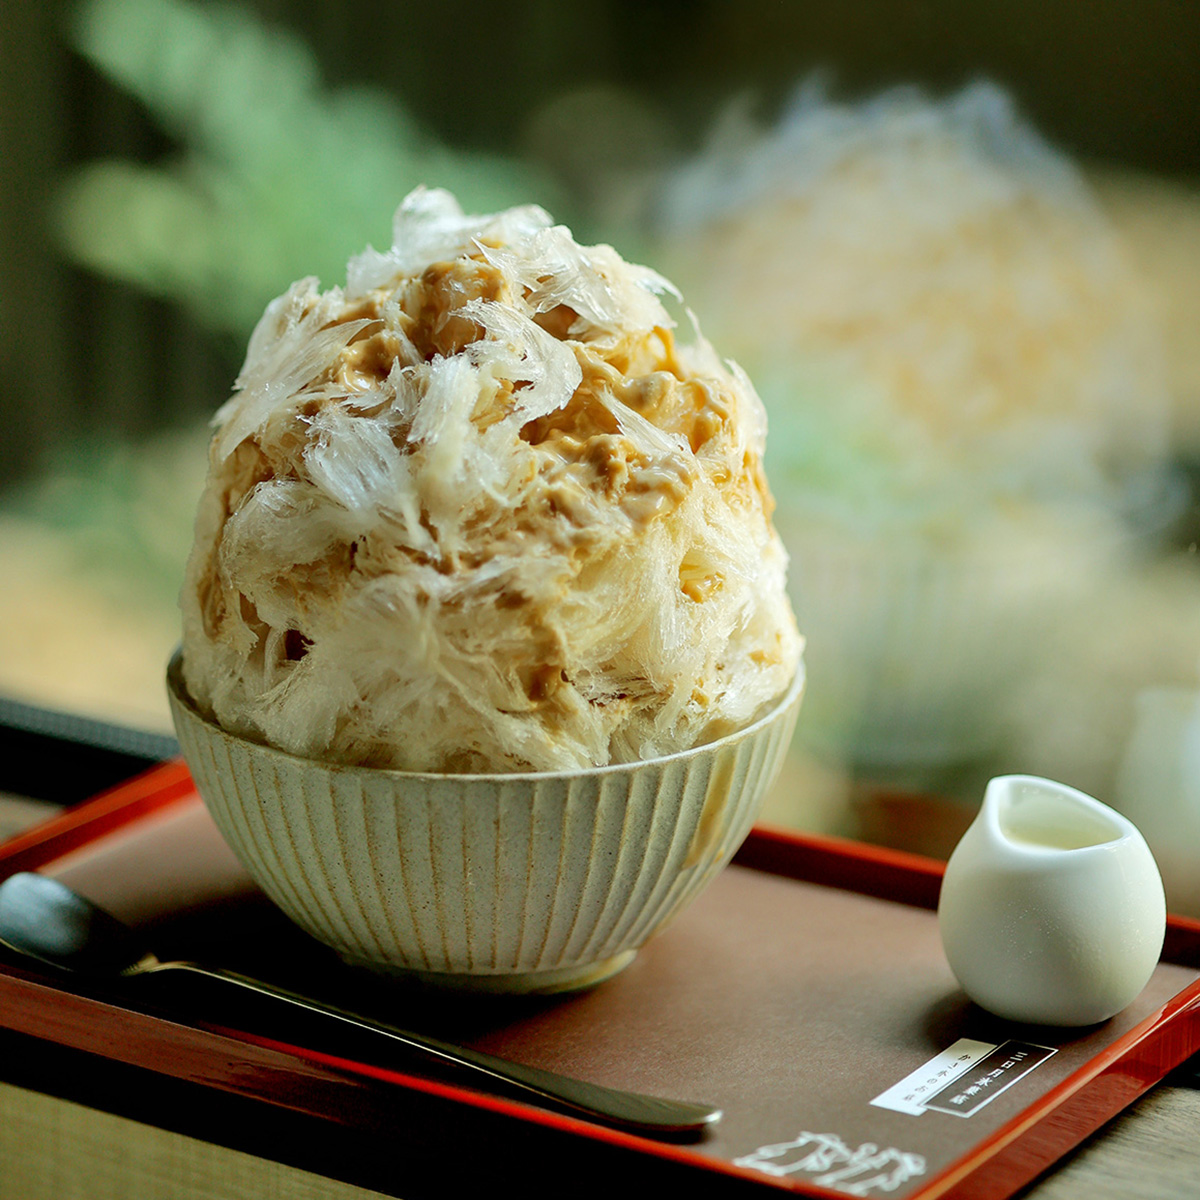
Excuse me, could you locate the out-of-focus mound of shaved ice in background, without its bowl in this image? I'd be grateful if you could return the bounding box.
[659,83,1170,516]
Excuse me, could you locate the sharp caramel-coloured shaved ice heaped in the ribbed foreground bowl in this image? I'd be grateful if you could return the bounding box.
[181,182,802,773]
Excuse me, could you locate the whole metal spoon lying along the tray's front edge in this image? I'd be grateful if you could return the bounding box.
[0,872,721,1136]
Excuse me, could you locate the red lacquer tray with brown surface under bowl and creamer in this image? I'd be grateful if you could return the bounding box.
[0,763,1200,1200]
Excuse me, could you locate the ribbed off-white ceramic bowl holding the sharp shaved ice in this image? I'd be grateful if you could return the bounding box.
[167,655,804,992]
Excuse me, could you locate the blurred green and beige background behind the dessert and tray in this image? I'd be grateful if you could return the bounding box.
[0,0,1200,911]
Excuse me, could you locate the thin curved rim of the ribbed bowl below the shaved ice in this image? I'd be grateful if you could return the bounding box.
[167,646,806,784]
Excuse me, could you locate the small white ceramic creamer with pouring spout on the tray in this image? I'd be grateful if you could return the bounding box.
[938,775,1166,1026]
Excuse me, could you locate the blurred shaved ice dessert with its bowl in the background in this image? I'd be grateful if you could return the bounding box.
[654,82,1180,777]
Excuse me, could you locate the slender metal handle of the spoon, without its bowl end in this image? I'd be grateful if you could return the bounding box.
[140,960,721,1135]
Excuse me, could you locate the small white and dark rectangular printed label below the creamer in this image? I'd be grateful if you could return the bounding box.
[871,1038,1057,1117]
